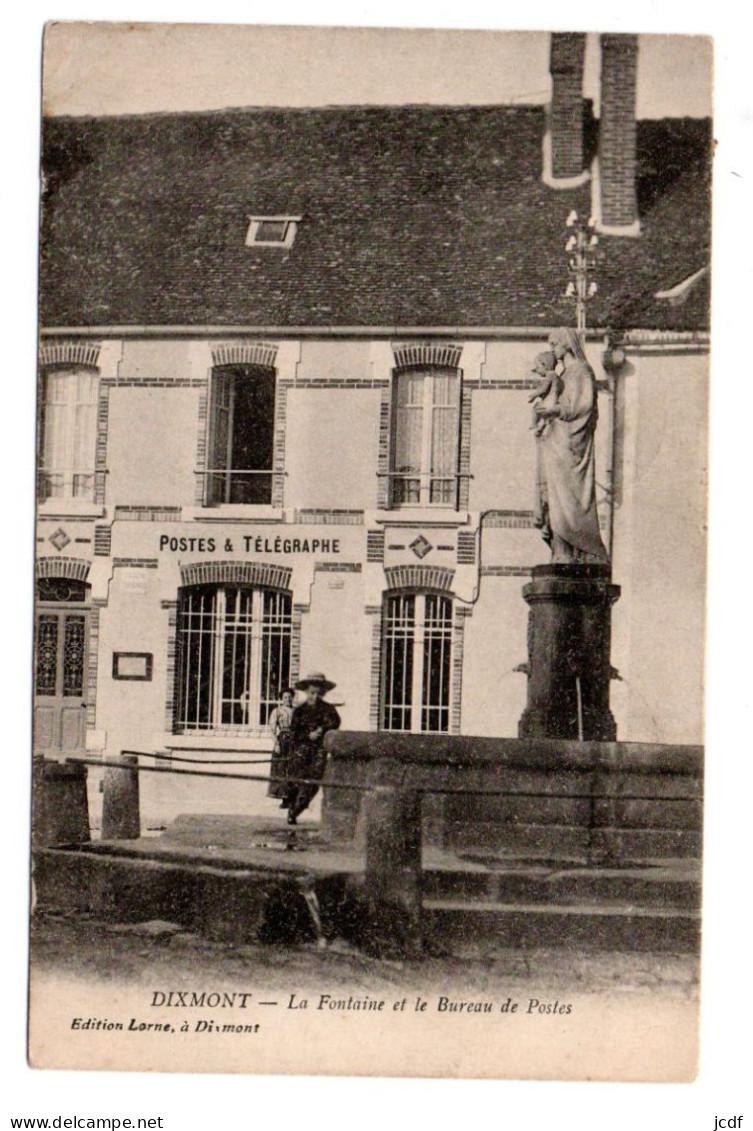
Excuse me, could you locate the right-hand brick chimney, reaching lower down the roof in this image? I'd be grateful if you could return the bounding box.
[592,35,640,235]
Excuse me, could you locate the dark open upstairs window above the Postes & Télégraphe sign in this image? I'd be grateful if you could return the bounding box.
[205,365,275,506]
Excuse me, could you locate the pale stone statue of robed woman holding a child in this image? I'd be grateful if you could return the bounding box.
[534,329,608,563]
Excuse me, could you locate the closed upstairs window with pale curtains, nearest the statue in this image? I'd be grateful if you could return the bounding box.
[390,369,460,507]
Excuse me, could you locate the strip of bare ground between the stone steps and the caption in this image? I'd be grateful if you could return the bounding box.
[32,913,698,1001]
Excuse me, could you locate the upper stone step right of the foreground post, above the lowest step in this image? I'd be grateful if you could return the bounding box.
[422,864,701,909]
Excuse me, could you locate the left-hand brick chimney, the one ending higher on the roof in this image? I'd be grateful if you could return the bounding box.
[544,32,588,189]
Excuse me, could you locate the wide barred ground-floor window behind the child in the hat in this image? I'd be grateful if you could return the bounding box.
[176,585,292,732]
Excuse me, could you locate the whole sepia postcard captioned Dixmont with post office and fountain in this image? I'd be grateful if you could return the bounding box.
[29,23,713,1081]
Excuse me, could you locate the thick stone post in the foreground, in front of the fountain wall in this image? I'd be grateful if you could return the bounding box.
[363,761,422,957]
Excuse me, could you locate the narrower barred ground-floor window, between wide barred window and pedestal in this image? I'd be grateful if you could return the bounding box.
[382,593,452,732]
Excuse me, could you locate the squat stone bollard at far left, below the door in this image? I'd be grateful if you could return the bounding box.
[32,757,92,848]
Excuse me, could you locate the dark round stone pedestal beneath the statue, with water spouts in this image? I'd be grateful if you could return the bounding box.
[518,564,620,742]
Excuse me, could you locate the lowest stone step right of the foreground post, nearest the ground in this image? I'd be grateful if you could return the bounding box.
[422,899,701,953]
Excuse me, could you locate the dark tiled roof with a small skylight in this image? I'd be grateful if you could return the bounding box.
[41,106,711,329]
